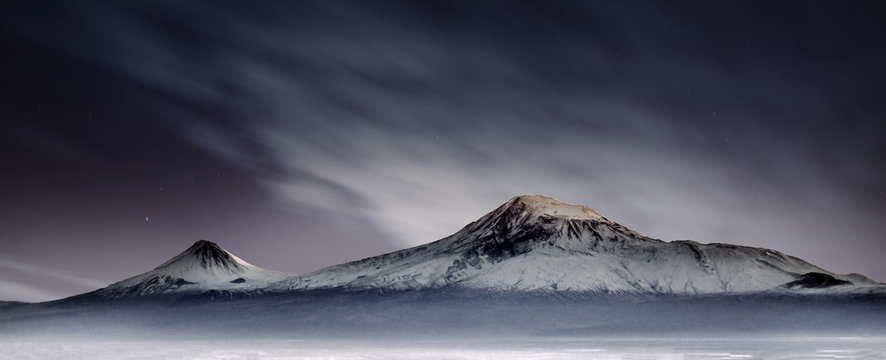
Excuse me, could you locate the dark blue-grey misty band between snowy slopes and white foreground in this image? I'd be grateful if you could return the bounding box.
[0,290,886,341]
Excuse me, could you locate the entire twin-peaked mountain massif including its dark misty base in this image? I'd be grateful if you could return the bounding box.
[6,196,886,342]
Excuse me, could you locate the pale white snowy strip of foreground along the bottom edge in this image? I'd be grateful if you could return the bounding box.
[0,337,886,360]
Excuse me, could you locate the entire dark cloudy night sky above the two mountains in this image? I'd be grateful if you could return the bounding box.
[0,0,886,301]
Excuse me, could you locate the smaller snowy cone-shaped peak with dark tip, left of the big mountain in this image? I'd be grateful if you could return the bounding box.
[94,240,292,298]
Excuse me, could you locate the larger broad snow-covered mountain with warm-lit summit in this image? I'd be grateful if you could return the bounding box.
[280,196,875,294]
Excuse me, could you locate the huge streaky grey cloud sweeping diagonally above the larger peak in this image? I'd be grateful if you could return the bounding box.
[3,2,886,276]
